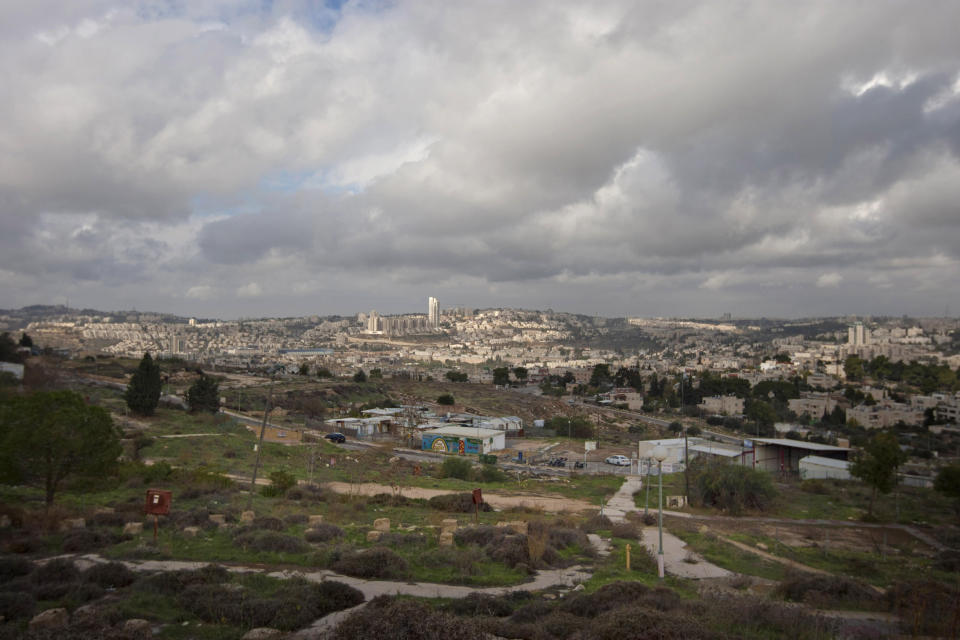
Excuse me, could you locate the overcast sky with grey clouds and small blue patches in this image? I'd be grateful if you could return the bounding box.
[0,0,960,318]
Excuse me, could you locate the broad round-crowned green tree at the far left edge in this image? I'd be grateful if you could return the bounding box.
[0,391,123,507]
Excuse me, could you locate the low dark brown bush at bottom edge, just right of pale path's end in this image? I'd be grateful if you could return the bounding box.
[333,596,487,640]
